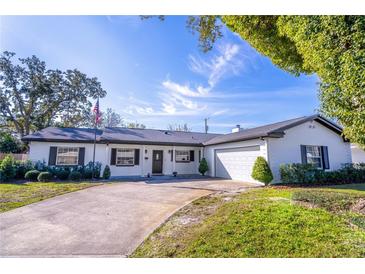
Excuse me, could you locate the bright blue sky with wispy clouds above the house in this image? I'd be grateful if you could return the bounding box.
[0,16,319,133]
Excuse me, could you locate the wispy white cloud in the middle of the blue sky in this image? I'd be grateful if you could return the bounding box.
[119,43,256,120]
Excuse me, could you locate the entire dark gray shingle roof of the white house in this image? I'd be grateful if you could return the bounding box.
[23,115,342,146]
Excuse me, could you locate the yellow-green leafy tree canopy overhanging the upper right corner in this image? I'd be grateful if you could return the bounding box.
[188,16,365,146]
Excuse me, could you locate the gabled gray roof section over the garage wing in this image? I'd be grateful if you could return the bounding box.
[203,115,342,145]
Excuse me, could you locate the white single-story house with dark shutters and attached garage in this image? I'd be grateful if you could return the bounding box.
[23,115,351,182]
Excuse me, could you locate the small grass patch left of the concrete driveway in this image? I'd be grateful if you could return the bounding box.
[0,182,97,212]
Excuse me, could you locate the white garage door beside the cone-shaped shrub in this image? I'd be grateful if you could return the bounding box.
[215,146,260,182]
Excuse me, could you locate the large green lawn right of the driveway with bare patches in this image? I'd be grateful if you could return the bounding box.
[132,185,365,258]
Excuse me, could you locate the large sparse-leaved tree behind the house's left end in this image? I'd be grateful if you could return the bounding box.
[0,51,106,137]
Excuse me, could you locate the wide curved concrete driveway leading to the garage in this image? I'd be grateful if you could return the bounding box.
[0,180,260,257]
